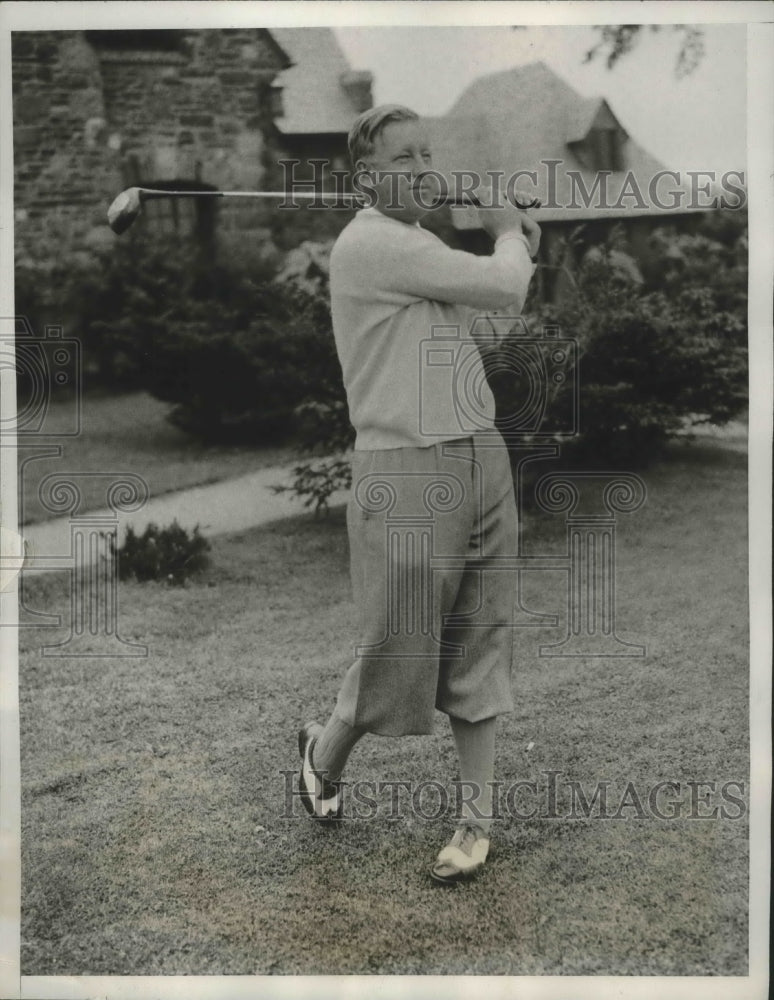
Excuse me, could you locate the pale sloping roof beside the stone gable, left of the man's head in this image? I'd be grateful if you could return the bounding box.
[271,28,372,135]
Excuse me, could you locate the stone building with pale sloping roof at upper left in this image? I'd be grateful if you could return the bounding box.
[12,28,371,264]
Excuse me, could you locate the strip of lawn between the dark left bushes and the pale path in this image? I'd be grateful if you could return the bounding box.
[19,392,292,524]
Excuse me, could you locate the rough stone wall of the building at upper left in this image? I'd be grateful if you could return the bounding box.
[12,29,286,263]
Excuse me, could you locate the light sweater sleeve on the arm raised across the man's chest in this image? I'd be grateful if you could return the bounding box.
[380,231,534,313]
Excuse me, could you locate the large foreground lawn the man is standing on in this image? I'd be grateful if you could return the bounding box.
[20,446,749,975]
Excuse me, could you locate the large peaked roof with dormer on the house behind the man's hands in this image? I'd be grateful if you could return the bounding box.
[425,62,696,229]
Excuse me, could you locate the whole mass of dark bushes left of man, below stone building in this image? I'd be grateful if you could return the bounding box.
[17,232,346,443]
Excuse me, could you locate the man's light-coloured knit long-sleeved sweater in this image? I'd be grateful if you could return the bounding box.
[330,208,534,450]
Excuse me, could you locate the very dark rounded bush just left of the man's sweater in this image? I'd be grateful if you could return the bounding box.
[146,268,341,442]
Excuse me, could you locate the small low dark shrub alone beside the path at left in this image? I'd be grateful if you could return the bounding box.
[118,520,210,586]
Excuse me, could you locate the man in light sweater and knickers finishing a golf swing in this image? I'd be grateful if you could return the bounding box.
[299,105,540,883]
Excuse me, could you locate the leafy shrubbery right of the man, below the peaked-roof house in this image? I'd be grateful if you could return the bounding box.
[516,220,747,465]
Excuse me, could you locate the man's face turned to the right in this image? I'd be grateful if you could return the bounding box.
[358,121,439,222]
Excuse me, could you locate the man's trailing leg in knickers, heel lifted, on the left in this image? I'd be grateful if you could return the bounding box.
[299,442,474,818]
